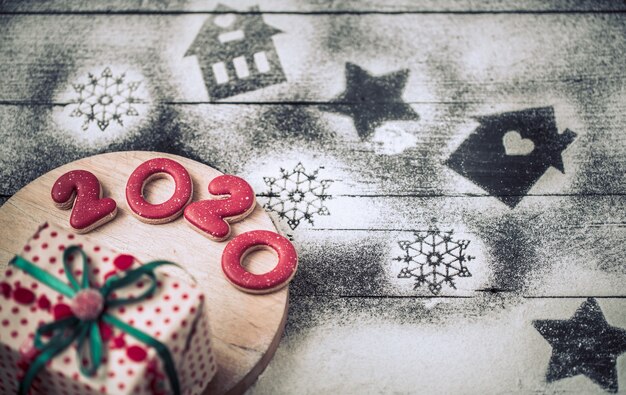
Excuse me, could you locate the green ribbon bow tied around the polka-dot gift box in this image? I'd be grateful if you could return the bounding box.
[10,245,180,395]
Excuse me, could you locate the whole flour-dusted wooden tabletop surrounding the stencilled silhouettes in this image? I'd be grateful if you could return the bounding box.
[0,0,626,394]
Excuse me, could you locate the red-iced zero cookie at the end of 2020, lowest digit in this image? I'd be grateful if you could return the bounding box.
[222,230,298,294]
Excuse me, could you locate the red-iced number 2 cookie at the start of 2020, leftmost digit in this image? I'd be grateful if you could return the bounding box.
[51,170,117,233]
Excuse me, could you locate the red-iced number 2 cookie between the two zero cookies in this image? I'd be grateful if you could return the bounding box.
[185,175,256,241]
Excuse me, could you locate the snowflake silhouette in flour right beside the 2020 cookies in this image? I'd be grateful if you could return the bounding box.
[259,163,333,230]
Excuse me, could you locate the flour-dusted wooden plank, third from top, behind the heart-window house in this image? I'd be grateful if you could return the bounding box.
[0,100,626,198]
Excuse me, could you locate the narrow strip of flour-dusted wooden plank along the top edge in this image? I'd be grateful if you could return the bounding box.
[0,0,626,13]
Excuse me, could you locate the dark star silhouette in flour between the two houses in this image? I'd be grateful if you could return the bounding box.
[322,62,419,140]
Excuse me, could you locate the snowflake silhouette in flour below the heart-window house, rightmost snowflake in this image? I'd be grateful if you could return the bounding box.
[394,228,474,295]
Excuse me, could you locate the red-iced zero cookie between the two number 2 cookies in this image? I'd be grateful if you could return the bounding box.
[126,158,193,224]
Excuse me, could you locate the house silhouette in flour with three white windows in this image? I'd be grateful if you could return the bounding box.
[185,4,287,100]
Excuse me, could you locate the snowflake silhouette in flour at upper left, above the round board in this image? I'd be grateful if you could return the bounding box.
[70,67,144,131]
